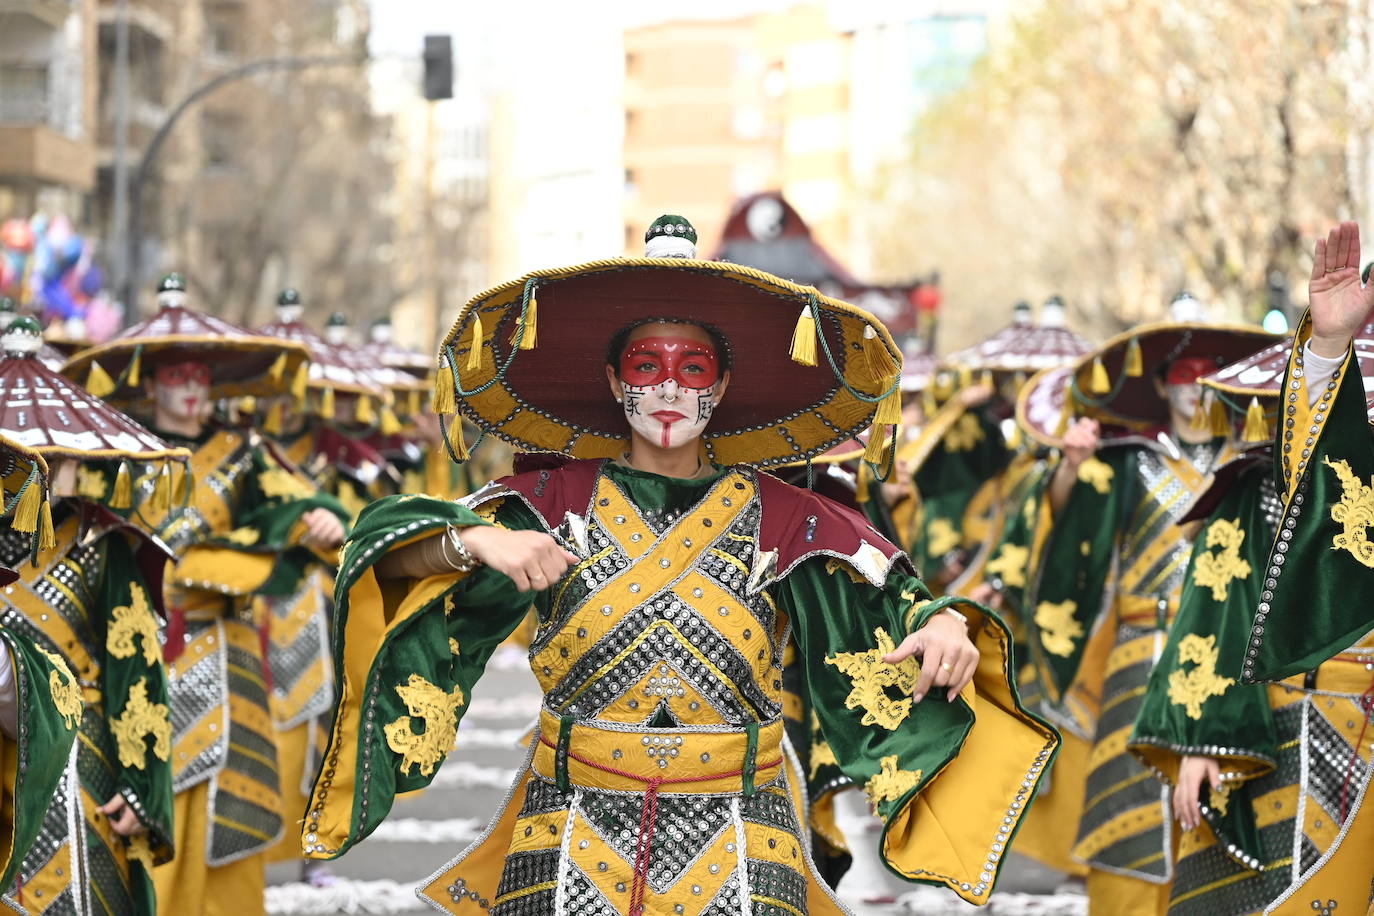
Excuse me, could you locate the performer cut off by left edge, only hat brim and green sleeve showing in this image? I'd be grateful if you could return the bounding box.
[0,437,82,912]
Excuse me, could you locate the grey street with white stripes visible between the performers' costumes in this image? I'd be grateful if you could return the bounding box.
[267,650,1087,916]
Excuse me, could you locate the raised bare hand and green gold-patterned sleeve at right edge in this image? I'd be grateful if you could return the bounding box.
[1241,222,1374,681]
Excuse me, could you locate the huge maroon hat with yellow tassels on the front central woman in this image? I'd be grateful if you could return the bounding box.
[436,224,901,467]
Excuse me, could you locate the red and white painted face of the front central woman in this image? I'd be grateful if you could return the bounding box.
[620,334,720,449]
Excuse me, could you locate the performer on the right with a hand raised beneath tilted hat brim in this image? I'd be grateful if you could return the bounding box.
[1028,304,1271,913]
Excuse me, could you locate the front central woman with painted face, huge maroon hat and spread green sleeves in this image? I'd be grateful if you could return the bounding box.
[304,217,1058,916]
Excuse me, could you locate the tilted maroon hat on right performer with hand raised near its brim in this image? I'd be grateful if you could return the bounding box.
[1069,321,1275,438]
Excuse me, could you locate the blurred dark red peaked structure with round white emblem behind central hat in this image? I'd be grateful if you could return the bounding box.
[710,191,938,341]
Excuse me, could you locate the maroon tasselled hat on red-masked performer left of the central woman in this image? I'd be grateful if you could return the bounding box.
[62,273,309,401]
